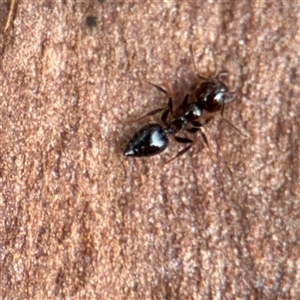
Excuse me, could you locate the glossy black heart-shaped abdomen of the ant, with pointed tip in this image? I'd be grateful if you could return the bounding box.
[124,123,169,157]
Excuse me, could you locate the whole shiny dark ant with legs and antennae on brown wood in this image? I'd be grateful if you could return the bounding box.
[124,46,247,162]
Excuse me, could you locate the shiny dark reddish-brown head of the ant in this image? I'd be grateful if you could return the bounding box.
[195,73,233,112]
